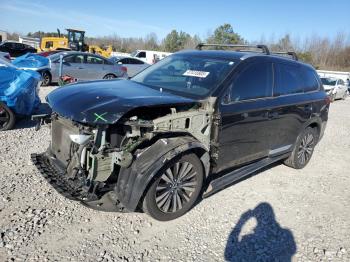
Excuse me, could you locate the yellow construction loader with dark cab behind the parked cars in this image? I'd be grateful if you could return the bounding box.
[38,28,113,57]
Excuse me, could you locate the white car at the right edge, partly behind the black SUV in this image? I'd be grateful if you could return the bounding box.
[321,77,348,101]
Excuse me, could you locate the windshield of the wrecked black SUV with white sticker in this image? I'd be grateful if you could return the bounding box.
[131,55,235,97]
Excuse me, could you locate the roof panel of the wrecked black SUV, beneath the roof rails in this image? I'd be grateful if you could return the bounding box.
[174,50,314,69]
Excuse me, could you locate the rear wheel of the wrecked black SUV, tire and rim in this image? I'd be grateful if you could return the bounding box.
[284,127,318,169]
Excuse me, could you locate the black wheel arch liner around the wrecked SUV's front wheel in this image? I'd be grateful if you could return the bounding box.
[114,136,210,211]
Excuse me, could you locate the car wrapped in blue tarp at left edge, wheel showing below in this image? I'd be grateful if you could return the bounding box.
[0,59,41,131]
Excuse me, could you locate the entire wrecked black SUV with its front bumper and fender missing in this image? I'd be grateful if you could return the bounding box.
[32,44,330,221]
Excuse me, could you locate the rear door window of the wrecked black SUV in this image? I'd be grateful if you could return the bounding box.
[274,63,304,96]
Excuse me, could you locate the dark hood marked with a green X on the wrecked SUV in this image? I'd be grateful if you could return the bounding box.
[46,80,196,124]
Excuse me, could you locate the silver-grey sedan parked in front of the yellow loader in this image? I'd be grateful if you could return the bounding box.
[47,51,128,83]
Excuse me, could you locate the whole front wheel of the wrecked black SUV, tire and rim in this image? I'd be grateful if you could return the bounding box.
[143,154,204,221]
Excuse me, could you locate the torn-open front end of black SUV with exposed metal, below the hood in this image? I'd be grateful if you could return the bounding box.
[32,97,215,212]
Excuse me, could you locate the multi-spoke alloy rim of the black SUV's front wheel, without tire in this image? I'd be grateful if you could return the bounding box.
[155,162,198,213]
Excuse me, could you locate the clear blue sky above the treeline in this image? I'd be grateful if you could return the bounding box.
[0,0,350,41]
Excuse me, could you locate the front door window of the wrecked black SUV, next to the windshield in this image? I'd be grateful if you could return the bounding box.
[230,62,273,102]
